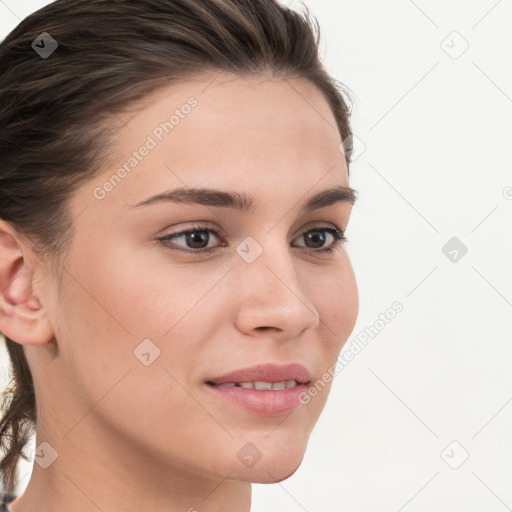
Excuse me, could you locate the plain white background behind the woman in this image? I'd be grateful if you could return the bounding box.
[0,0,512,512]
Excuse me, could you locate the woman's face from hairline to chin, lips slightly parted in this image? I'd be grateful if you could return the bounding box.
[25,71,358,482]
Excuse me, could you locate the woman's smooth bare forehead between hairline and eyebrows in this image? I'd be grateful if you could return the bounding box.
[78,75,348,216]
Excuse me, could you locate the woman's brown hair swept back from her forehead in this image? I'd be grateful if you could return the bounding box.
[0,0,352,493]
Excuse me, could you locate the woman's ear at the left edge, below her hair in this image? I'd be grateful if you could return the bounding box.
[0,219,54,345]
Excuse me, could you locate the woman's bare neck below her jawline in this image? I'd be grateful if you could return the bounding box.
[10,427,251,512]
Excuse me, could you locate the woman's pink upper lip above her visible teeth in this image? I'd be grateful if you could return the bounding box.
[207,363,311,384]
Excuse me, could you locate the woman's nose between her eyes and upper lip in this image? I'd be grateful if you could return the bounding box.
[234,237,320,339]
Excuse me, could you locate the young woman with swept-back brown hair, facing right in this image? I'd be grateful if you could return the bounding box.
[0,0,358,512]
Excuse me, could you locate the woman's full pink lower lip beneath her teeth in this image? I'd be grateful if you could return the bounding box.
[205,384,307,416]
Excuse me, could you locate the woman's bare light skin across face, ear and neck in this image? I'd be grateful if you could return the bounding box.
[0,74,358,512]
